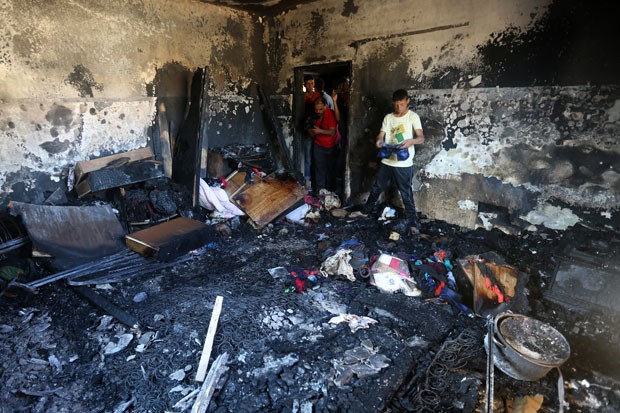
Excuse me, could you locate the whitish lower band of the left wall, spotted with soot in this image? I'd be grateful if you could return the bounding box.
[0,98,155,195]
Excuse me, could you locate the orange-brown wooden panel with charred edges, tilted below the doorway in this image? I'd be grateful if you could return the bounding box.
[233,174,307,228]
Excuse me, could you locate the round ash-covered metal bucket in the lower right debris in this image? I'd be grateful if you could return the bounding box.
[484,313,570,381]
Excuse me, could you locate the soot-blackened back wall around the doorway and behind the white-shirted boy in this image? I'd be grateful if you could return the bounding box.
[268,0,620,228]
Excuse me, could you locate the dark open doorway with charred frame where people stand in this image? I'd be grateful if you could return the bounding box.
[293,61,352,199]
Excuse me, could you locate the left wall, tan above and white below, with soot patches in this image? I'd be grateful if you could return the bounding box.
[0,0,264,205]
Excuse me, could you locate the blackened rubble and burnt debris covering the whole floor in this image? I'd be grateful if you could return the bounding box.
[0,160,620,412]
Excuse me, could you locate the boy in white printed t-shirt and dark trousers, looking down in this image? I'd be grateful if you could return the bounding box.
[360,89,424,235]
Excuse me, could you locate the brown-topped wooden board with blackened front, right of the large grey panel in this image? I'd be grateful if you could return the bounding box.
[125,217,216,261]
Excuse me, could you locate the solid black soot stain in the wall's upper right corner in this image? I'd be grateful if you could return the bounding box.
[478,0,620,87]
